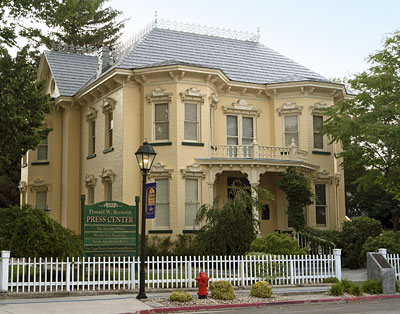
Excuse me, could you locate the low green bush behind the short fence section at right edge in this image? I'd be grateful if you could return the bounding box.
[361,231,400,256]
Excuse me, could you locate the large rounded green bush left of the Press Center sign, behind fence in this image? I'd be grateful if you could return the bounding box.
[0,206,83,259]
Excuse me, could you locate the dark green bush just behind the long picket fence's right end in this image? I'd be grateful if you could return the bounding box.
[339,217,382,269]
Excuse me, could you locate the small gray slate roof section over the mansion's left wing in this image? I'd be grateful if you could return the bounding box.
[44,51,97,96]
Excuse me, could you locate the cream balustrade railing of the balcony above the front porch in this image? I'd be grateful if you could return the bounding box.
[210,142,307,161]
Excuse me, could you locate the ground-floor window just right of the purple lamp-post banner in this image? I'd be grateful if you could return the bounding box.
[155,179,169,228]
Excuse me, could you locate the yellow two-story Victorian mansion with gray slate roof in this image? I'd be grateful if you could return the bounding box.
[19,21,349,235]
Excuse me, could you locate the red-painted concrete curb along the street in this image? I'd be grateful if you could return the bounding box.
[130,294,400,314]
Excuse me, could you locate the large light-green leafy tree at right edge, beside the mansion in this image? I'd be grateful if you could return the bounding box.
[324,32,400,230]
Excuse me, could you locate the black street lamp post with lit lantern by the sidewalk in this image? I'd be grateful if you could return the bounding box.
[135,140,157,299]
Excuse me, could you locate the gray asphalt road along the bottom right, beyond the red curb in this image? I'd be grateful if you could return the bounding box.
[181,299,400,314]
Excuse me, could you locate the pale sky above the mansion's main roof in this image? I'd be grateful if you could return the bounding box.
[107,0,400,78]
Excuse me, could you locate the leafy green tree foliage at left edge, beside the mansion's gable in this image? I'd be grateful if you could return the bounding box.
[0,47,52,166]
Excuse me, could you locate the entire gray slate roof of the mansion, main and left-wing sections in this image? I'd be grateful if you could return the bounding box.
[45,28,329,96]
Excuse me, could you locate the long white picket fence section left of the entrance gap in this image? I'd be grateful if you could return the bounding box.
[0,249,341,292]
